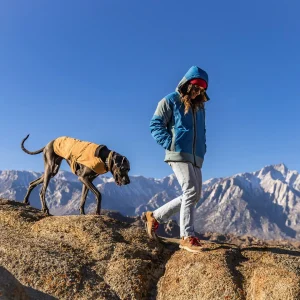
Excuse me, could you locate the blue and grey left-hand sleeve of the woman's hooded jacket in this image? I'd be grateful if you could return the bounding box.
[150,98,173,150]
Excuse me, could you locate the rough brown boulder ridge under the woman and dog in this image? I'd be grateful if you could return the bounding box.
[0,199,300,300]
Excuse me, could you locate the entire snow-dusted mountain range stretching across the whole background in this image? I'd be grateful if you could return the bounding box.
[0,164,300,239]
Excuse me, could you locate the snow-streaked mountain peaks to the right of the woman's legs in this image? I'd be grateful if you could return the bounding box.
[195,164,300,239]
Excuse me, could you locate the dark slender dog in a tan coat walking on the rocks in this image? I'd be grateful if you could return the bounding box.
[21,134,130,215]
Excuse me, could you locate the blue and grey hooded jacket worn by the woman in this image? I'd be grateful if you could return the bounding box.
[150,66,208,168]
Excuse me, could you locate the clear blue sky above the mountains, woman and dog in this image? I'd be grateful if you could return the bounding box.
[0,0,300,179]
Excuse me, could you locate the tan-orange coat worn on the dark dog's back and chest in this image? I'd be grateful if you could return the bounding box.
[53,136,107,174]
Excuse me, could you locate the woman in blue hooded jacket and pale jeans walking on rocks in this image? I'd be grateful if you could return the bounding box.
[142,66,209,252]
